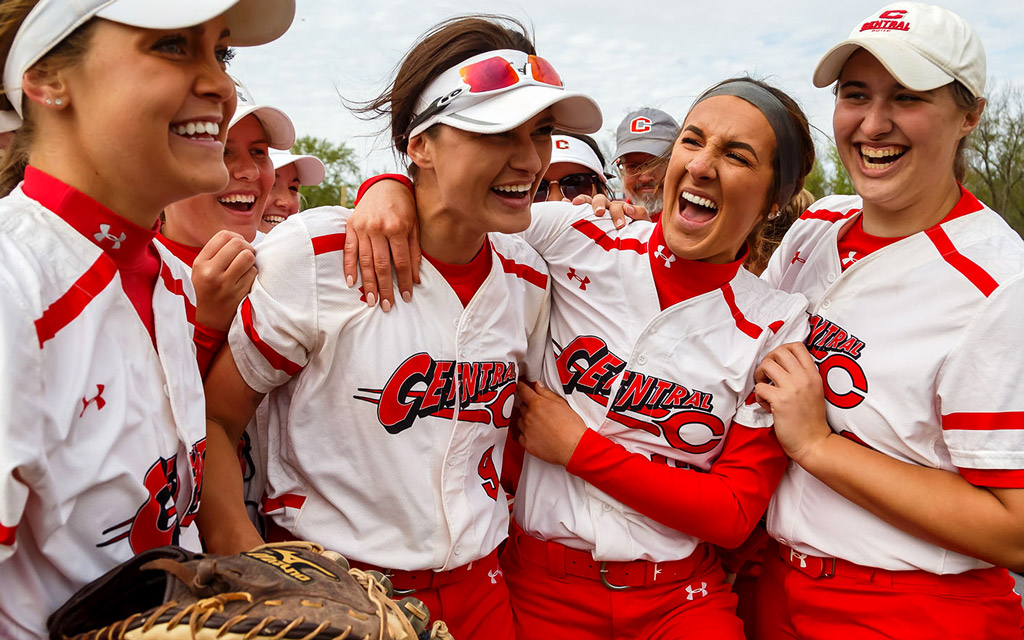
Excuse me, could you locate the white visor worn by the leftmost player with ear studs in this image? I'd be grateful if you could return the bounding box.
[3,0,295,117]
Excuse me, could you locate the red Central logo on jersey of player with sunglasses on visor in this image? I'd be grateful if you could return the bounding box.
[353,353,519,434]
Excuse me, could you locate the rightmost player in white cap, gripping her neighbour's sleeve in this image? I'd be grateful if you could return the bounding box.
[757,2,1024,639]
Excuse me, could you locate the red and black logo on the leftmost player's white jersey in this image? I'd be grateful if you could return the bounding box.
[96,438,206,553]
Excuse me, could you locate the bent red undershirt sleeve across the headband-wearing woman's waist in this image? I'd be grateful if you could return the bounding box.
[566,423,786,549]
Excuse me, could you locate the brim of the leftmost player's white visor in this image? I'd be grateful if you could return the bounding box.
[96,0,295,46]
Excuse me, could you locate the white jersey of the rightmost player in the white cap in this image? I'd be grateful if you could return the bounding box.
[764,193,1024,573]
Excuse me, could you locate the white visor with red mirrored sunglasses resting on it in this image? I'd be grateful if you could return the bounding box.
[407,49,602,137]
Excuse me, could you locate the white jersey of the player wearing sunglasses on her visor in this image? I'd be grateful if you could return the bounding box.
[228,207,549,569]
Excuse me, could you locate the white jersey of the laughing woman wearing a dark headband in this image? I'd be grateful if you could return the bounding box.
[515,203,807,562]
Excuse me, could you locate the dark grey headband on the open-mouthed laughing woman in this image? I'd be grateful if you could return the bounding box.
[690,80,801,209]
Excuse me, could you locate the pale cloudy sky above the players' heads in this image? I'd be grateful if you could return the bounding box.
[230,0,1024,175]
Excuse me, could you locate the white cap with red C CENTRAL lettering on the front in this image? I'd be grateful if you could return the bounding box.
[814,2,985,97]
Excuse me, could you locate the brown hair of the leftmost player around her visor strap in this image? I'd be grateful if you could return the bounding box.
[0,0,96,197]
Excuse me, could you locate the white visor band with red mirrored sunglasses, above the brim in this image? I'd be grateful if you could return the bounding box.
[406,49,563,138]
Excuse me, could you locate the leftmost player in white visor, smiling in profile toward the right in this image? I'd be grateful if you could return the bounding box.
[0,0,294,638]
